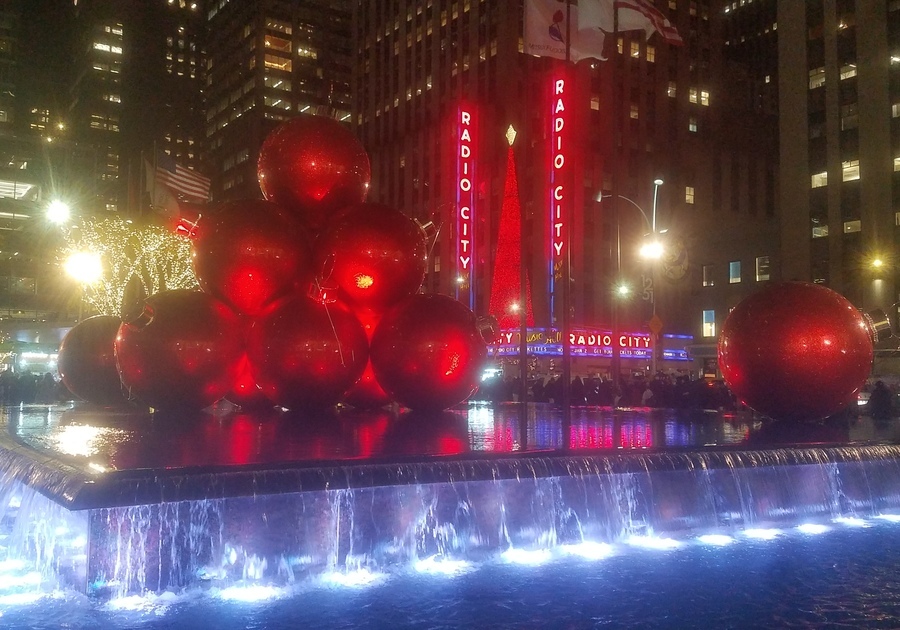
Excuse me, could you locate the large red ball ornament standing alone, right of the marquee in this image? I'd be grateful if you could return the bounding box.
[718,282,875,420]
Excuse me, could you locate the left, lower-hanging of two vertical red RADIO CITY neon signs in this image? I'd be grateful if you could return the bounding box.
[456,107,475,308]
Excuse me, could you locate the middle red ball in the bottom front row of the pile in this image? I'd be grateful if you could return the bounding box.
[247,296,369,410]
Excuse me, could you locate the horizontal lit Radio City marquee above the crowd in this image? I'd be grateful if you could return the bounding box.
[488,328,690,361]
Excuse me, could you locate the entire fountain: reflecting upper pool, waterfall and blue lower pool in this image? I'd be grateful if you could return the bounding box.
[0,405,900,629]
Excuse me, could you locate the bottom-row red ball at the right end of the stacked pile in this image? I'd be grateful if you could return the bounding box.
[370,294,487,410]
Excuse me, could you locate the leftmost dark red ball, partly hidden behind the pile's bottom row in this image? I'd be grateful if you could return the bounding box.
[57,315,128,406]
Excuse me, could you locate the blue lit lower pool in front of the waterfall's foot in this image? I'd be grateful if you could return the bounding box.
[0,519,900,630]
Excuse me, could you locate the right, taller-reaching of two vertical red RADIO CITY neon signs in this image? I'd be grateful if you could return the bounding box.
[549,78,569,315]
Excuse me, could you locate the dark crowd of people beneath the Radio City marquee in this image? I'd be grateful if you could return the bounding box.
[475,371,738,411]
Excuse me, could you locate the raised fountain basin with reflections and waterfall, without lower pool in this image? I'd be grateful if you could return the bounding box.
[0,403,900,612]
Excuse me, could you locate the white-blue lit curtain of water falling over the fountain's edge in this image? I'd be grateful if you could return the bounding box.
[0,446,884,596]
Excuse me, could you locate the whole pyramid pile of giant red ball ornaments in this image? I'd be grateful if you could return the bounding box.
[59,116,487,410]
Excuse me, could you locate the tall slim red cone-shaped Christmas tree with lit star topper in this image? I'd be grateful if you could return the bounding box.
[489,125,534,329]
